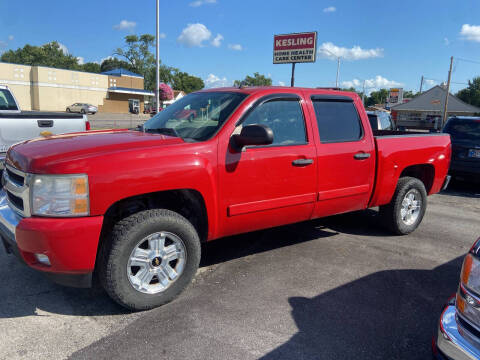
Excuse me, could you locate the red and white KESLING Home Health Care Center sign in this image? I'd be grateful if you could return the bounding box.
[273,31,317,64]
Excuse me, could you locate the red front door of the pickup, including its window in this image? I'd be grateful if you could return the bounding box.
[219,94,317,236]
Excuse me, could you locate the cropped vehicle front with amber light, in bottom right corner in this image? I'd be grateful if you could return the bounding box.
[433,239,480,360]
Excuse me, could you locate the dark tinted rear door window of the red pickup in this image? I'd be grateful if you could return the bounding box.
[312,97,363,143]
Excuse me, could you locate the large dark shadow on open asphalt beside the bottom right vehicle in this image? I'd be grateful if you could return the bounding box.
[261,257,463,360]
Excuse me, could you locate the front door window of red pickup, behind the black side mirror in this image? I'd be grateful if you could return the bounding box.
[234,99,307,146]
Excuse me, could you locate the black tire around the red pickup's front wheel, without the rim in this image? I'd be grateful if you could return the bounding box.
[98,209,201,310]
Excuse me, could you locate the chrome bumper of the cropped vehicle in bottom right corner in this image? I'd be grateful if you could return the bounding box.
[436,304,480,360]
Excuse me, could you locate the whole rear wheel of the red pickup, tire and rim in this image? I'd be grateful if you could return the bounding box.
[380,177,427,235]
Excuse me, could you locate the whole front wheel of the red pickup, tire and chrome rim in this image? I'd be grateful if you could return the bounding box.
[99,209,201,310]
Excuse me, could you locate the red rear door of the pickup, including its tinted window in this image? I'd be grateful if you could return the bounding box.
[309,95,375,217]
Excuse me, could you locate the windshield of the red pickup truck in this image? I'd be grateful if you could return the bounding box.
[143,92,247,141]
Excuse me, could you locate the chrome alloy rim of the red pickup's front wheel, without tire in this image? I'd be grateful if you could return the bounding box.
[127,231,187,294]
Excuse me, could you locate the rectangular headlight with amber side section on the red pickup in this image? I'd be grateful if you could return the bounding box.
[31,175,90,217]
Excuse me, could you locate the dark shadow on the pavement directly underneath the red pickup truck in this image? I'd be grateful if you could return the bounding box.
[0,211,428,318]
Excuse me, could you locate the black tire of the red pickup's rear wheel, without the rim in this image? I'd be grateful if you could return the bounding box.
[380,177,427,235]
